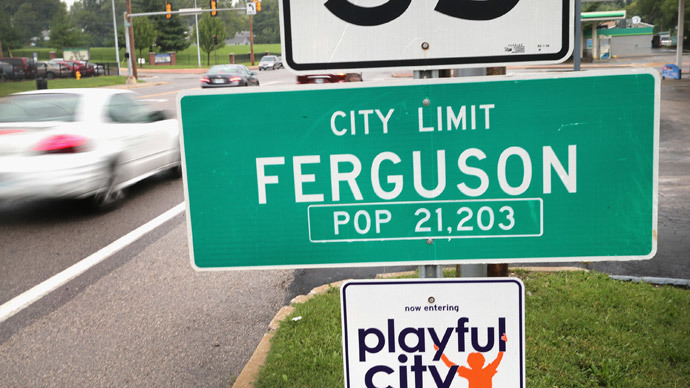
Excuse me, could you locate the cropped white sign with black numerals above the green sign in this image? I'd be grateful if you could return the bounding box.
[280,0,574,73]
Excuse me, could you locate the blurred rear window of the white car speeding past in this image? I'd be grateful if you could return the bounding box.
[0,93,80,123]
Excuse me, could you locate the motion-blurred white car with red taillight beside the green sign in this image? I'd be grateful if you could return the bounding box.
[0,89,180,209]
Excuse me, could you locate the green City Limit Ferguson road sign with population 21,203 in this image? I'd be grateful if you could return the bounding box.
[178,70,660,269]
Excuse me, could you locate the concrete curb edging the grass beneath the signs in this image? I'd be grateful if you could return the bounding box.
[232,267,589,388]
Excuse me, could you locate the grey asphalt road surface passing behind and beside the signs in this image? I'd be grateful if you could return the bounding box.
[0,63,690,387]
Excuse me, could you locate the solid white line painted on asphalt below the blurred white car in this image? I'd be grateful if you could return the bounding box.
[0,202,185,323]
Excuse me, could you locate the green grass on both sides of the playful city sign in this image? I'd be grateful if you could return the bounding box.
[256,271,690,388]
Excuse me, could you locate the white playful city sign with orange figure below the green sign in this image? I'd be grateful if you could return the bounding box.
[341,278,525,388]
